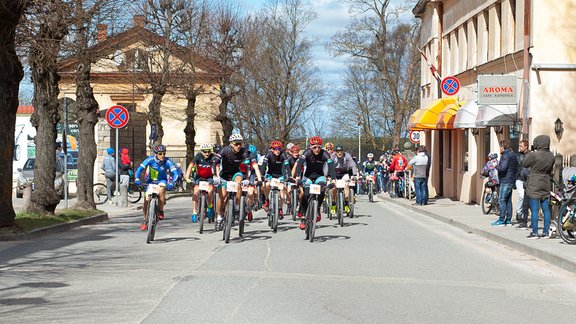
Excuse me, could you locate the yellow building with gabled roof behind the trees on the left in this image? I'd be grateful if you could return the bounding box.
[60,16,222,180]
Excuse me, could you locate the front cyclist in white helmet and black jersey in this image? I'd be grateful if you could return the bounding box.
[212,134,262,227]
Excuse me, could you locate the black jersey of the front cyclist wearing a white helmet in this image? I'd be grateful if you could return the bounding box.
[212,146,257,181]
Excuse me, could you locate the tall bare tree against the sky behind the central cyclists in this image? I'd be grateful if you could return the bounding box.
[234,0,324,147]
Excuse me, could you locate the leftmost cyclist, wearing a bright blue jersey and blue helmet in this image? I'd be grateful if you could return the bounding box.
[134,144,178,231]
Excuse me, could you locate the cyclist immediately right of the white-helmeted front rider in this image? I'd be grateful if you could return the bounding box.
[262,141,286,219]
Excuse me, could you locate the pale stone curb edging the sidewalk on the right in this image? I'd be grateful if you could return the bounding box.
[378,195,576,273]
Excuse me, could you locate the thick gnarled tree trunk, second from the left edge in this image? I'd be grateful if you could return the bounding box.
[27,0,71,214]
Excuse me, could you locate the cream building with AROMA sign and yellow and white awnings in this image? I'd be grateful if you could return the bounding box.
[408,0,576,202]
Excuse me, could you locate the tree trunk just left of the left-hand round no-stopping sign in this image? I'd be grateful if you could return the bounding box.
[74,61,98,209]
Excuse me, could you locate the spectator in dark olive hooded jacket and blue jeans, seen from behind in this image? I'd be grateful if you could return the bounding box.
[522,135,554,239]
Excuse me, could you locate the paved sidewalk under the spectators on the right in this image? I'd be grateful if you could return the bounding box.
[378,194,576,273]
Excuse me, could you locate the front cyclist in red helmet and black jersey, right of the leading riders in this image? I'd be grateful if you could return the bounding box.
[292,136,336,230]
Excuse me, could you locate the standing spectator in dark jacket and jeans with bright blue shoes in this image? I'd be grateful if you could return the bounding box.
[492,139,518,226]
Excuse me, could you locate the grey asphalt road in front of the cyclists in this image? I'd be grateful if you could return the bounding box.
[0,197,576,323]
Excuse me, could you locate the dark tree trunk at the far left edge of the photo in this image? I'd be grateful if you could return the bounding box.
[0,0,29,227]
